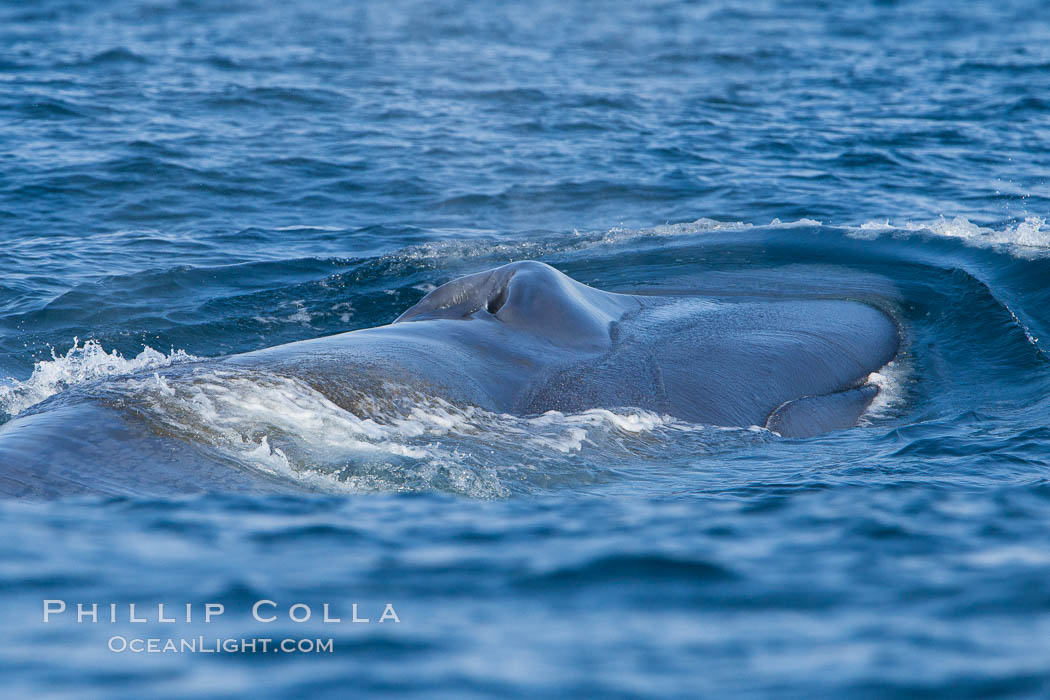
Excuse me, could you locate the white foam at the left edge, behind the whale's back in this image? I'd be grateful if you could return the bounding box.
[0,338,197,416]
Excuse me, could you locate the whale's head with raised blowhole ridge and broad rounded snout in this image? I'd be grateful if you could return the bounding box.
[393,261,900,437]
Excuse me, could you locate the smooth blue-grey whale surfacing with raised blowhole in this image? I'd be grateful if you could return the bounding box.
[0,260,901,499]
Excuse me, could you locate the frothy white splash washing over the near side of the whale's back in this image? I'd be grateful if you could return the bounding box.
[108,366,747,499]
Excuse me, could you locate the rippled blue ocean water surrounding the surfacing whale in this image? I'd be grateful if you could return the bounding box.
[0,0,1050,698]
